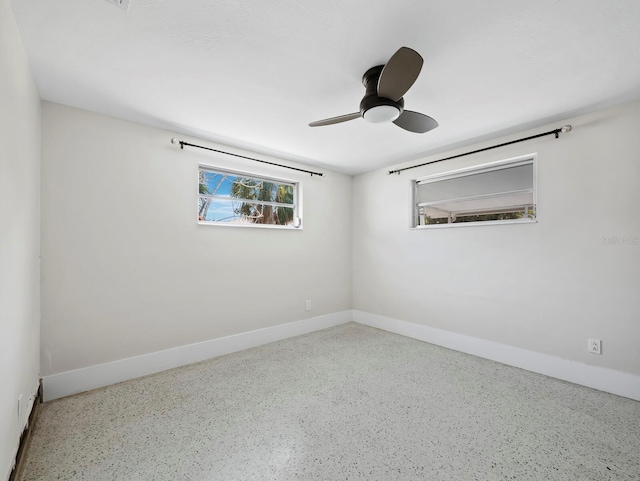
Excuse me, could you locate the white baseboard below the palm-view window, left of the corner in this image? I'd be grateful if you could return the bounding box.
[43,310,353,401]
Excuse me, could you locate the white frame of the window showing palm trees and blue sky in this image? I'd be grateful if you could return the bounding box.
[196,164,304,230]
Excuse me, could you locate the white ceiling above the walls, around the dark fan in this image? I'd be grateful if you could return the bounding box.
[12,0,640,174]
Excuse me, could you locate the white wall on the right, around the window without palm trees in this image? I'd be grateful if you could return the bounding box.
[353,103,640,374]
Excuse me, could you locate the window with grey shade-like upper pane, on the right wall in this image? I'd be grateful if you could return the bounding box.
[414,155,536,227]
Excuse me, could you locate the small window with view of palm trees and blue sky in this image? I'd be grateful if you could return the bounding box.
[198,166,302,228]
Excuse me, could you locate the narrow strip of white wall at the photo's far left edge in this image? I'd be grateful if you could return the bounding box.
[0,0,40,479]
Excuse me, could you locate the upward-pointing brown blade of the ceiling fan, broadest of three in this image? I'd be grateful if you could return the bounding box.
[378,47,424,102]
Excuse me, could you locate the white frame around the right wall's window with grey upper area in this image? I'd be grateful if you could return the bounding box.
[411,153,538,230]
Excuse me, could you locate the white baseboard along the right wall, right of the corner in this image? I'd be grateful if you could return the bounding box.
[353,310,640,401]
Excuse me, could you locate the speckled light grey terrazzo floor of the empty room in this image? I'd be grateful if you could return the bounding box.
[20,323,640,481]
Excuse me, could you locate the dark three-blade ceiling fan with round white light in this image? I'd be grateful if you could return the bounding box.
[309,47,438,134]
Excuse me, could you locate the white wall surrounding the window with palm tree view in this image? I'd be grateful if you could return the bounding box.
[41,102,351,376]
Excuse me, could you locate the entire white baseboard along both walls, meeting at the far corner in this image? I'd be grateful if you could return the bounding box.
[43,310,640,401]
